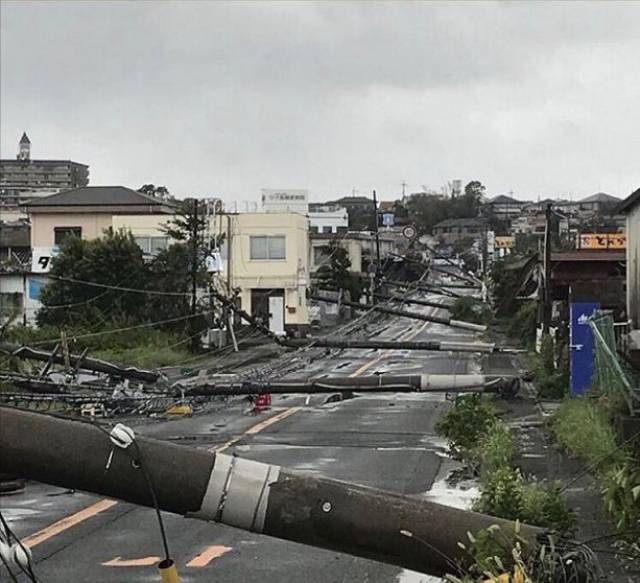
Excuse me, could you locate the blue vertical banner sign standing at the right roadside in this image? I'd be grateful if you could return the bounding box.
[570,302,600,396]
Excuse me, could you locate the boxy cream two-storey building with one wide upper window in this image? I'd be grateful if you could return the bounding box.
[214,212,309,334]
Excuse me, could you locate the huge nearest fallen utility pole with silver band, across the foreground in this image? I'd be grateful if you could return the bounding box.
[0,407,546,576]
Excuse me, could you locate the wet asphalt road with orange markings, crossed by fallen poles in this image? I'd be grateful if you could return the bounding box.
[0,292,510,583]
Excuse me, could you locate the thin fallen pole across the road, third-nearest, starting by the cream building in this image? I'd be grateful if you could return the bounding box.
[286,338,510,354]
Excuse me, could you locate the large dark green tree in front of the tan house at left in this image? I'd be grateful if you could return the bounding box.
[37,229,149,327]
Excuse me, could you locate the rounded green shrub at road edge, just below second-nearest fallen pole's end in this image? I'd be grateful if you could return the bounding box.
[436,394,497,459]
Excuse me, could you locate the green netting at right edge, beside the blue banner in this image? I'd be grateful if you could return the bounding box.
[589,313,640,415]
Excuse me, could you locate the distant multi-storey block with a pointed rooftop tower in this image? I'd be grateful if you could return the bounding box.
[0,133,89,215]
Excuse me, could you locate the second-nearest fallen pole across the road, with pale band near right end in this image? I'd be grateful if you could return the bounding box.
[179,374,519,396]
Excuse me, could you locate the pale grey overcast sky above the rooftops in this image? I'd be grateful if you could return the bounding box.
[0,1,640,200]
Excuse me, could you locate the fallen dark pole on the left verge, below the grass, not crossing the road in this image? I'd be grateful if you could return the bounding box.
[0,344,160,383]
